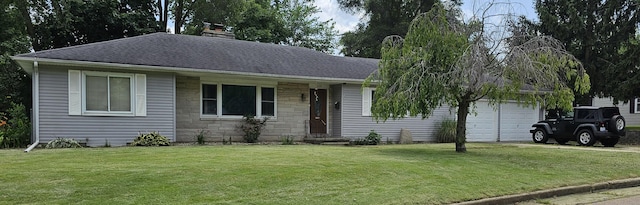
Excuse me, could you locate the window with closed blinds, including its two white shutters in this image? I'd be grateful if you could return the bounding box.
[69,70,146,116]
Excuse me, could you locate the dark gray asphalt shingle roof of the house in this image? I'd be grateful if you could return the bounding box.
[18,33,378,79]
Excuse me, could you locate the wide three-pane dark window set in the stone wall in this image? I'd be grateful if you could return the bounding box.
[201,83,276,117]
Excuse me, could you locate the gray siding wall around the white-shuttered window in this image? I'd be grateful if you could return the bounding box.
[39,66,175,146]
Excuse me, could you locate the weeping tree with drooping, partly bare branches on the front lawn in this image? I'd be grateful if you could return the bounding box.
[363,4,590,152]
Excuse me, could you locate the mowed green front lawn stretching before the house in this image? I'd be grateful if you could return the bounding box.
[0,144,640,204]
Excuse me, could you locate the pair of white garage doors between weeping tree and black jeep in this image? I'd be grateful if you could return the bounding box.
[467,101,541,142]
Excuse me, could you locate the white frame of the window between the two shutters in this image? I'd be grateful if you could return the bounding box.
[82,71,136,116]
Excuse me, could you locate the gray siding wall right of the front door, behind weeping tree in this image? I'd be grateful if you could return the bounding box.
[341,85,452,142]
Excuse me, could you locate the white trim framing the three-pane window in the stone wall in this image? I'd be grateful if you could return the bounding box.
[199,81,278,120]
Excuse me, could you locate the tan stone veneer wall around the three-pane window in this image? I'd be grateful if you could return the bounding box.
[176,76,309,142]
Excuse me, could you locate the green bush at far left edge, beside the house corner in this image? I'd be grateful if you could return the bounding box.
[0,103,31,148]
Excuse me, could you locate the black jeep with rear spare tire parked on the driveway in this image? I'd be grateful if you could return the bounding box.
[529,107,625,147]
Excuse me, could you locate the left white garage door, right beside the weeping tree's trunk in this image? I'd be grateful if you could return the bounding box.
[467,101,498,142]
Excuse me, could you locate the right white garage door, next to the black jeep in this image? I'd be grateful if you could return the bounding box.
[499,103,540,142]
